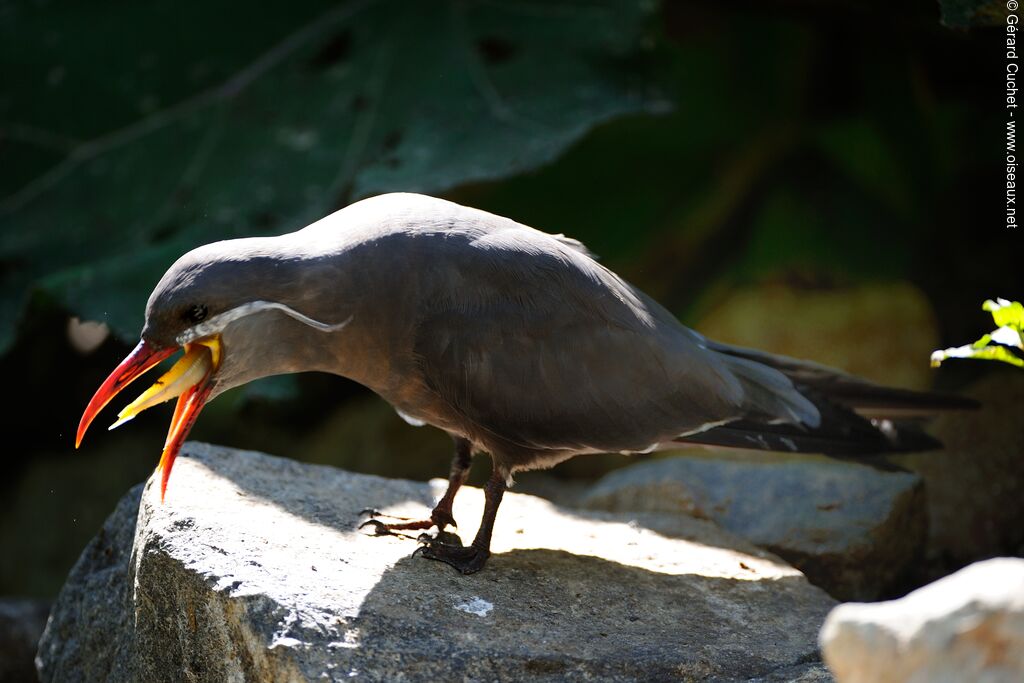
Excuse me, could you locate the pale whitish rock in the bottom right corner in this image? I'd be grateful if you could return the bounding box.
[821,558,1024,683]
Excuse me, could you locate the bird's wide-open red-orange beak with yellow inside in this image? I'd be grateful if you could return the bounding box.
[75,335,221,501]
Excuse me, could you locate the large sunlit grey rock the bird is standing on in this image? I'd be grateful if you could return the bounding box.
[38,443,835,681]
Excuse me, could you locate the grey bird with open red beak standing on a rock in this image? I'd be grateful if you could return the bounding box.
[76,194,969,573]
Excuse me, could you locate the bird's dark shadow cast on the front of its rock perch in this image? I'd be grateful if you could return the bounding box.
[335,549,820,680]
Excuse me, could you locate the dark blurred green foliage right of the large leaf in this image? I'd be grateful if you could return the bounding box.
[454,3,1015,326]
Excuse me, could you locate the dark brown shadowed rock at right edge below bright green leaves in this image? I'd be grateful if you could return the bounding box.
[894,368,1024,566]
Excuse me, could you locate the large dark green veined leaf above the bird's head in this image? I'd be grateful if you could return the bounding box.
[0,0,660,350]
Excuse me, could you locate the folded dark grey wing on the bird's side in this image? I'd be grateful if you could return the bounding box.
[407,230,814,451]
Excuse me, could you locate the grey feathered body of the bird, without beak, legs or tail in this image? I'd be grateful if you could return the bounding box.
[151,194,816,458]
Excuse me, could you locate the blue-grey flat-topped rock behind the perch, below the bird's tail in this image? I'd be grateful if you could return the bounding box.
[579,453,928,600]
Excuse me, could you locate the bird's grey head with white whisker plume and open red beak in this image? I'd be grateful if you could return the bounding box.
[75,239,348,500]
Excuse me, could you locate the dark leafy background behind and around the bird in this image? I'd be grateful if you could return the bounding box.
[0,0,1024,597]
